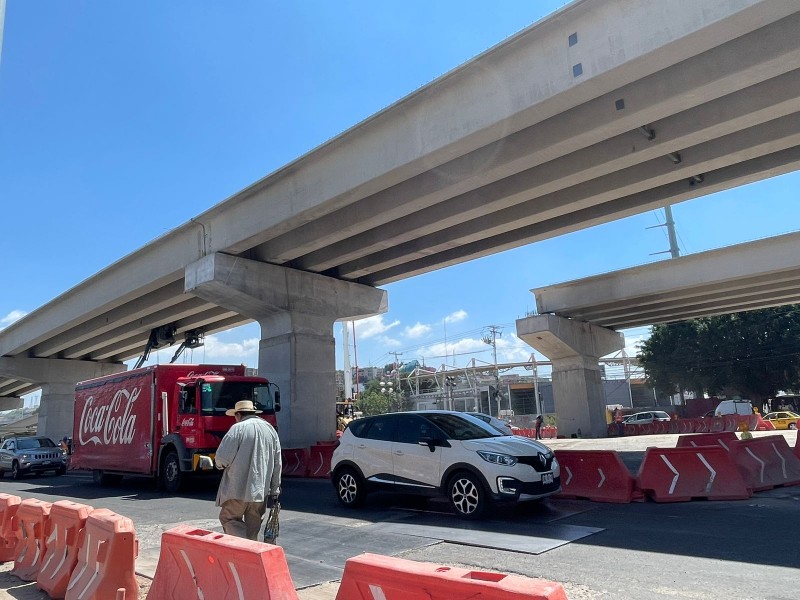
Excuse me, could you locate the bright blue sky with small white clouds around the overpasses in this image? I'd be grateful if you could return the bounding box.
[0,0,800,400]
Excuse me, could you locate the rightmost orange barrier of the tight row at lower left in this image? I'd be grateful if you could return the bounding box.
[65,508,139,600]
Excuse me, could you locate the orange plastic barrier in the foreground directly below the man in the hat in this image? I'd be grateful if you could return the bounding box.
[147,525,297,600]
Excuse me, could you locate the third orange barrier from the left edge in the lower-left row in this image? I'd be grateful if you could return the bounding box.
[36,500,93,598]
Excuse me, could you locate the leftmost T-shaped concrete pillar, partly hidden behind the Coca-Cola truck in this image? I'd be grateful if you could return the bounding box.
[0,357,126,442]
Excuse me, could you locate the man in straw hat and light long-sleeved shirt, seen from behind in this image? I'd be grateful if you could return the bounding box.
[216,400,281,540]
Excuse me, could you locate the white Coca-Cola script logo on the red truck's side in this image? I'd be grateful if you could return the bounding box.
[78,388,141,445]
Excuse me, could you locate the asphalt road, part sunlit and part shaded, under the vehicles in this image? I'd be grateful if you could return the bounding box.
[0,432,800,600]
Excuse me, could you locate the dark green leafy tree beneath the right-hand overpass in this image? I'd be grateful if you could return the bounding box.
[639,304,800,404]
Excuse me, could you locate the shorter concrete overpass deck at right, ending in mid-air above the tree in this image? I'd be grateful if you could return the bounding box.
[532,233,800,327]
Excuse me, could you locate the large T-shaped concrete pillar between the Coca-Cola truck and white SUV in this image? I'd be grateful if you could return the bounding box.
[186,254,387,447]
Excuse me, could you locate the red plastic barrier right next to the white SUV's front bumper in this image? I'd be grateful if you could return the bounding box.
[556,450,636,504]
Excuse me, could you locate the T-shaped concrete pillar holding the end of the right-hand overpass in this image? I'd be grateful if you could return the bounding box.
[517,315,625,438]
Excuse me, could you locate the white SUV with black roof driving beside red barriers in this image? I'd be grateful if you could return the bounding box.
[331,410,561,519]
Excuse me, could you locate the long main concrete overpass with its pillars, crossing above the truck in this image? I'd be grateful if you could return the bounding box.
[0,0,800,443]
